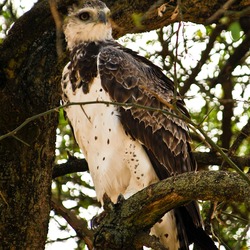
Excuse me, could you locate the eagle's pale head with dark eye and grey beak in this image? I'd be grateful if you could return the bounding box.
[63,0,112,50]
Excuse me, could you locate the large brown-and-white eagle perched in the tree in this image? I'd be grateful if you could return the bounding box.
[62,0,216,250]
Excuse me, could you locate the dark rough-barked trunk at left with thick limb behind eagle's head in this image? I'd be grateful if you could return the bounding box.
[0,0,247,249]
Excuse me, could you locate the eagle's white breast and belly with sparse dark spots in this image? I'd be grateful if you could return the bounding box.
[62,52,157,202]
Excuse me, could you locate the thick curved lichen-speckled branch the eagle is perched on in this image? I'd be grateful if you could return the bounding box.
[94,171,250,249]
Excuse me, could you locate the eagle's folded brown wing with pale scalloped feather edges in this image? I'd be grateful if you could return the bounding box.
[99,46,196,179]
